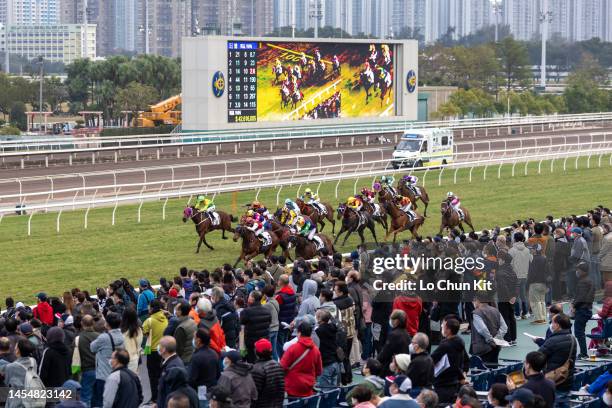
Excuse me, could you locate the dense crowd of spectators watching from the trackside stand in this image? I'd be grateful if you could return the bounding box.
[0,207,612,408]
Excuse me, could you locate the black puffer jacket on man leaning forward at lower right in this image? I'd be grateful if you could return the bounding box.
[538,329,578,391]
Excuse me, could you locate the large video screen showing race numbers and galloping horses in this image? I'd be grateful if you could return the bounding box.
[227,41,395,122]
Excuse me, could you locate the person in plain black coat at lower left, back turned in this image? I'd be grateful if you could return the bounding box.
[39,327,72,388]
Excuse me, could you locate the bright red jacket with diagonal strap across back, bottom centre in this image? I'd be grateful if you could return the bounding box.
[280,337,323,397]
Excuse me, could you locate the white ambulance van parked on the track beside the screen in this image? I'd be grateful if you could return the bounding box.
[391,128,453,169]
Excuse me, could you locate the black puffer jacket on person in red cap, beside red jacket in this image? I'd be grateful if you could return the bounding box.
[251,360,285,408]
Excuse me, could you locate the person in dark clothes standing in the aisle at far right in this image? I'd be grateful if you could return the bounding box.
[572,263,595,358]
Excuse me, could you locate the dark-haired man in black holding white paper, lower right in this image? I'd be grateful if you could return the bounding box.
[431,318,469,404]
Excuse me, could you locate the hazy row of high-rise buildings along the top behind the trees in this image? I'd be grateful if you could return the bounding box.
[0,0,612,61]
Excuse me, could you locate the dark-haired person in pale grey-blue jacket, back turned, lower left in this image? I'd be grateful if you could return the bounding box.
[89,312,124,407]
